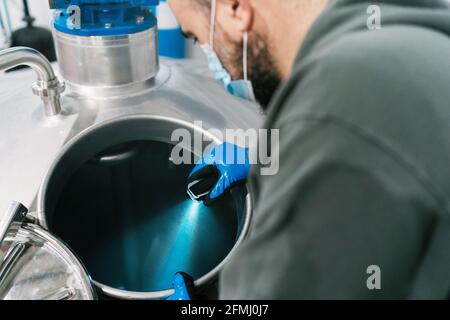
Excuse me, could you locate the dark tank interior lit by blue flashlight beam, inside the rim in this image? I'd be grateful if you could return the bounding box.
[49,140,239,292]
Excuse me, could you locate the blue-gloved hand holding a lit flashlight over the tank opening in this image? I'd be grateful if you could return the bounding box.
[188,142,250,205]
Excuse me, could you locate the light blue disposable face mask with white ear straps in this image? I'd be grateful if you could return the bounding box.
[200,0,256,102]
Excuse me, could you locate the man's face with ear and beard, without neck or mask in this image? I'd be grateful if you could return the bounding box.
[169,0,281,107]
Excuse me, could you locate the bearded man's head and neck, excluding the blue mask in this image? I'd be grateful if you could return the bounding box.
[168,0,329,107]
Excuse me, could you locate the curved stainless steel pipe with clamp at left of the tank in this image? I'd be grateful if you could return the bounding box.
[0,47,65,116]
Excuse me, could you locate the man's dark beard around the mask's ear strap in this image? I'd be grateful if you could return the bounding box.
[218,32,281,111]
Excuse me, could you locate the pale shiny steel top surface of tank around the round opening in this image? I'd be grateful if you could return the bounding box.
[0,54,263,298]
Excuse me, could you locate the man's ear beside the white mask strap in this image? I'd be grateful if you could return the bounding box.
[217,0,255,41]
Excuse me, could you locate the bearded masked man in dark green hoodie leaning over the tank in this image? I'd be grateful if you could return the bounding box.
[169,0,450,299]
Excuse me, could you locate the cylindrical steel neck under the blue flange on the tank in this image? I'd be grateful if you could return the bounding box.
[54,27,159,95]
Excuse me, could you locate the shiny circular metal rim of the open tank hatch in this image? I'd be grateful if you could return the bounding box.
[36,114,253,300]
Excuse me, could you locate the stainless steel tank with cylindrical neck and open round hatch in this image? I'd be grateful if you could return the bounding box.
[0,0,263,299]
